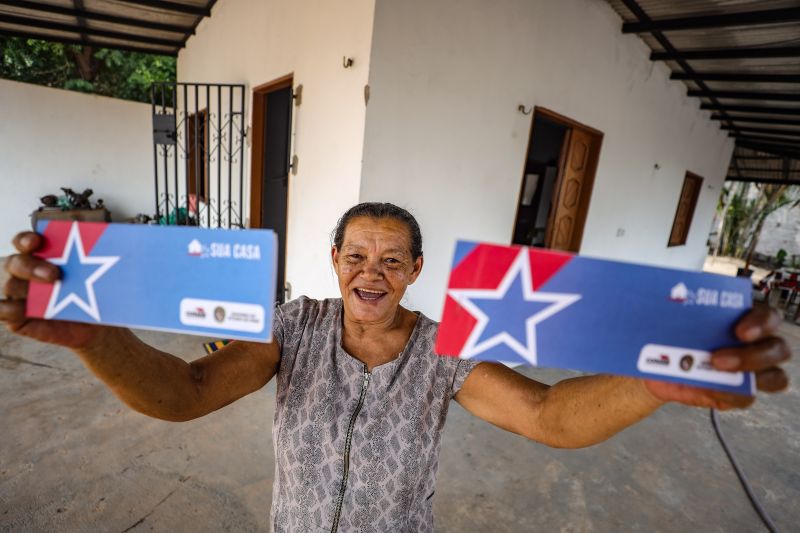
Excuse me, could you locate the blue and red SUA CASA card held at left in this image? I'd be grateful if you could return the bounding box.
[27,221,276,342]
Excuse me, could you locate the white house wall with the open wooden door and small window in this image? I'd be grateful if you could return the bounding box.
[360,0,733,317]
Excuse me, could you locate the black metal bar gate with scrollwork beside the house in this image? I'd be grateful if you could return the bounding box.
[150,82,246,228]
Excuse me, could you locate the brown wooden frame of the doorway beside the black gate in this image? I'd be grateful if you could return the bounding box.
[250,73,294,229]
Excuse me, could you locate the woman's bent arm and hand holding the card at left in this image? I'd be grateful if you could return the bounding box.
[0,232,280,421]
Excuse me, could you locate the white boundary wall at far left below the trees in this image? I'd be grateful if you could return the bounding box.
[0,80,154,256]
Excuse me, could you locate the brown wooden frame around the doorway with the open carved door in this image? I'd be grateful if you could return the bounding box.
[511,106,604,252]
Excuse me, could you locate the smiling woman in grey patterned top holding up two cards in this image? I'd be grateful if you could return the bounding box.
[0,203,789,531]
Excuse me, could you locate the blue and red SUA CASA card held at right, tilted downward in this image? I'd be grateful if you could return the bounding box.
[435,241,755,395]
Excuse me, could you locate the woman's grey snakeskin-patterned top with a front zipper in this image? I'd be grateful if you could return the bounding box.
[271,297,478,533]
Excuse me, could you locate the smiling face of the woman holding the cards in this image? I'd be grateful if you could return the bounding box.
[331,217,422,324]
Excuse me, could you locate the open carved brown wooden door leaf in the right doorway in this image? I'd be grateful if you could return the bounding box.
[547,128,596,252]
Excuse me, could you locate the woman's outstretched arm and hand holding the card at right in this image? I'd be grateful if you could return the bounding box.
[456,307,790,448]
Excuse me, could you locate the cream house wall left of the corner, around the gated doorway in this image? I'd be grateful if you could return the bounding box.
[178,0,374,298]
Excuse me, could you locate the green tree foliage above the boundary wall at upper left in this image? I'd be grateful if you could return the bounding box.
[0,36,176,102]
